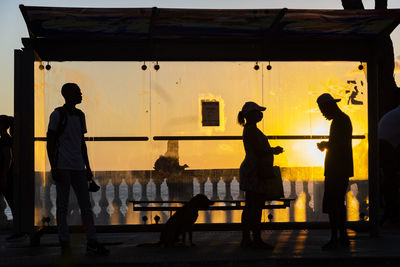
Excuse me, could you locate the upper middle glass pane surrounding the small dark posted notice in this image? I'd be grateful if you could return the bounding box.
[151,62,262,136]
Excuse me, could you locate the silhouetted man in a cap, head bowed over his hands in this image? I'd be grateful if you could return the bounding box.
[317,94,353,250]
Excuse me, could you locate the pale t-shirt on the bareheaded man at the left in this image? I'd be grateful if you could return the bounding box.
[48,110,87,170]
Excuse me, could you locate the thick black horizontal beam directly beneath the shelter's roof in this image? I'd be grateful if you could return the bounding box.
[22,38,376,62]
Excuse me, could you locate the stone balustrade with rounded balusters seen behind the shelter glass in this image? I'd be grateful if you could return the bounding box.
[0,168,368,228]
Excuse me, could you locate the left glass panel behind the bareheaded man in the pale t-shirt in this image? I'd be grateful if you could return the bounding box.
[35,62,152,224]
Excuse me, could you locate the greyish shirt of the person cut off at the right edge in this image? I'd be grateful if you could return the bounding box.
[378,106,400,148]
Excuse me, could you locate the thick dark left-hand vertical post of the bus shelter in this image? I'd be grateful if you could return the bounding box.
[13,50,35,233]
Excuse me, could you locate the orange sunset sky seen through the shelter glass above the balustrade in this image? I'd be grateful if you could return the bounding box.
[35,62,367,181]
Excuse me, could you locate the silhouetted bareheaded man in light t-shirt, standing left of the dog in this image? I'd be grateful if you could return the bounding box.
[47,83,109,255]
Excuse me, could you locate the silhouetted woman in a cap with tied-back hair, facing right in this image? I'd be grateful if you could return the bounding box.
[238,102,283,249]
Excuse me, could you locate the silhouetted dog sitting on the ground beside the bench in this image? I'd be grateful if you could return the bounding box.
[159,194,214,247]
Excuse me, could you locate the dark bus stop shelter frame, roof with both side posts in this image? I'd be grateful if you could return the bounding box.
[14,5,400,235]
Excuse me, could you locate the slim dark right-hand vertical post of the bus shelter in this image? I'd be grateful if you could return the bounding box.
[367,57,381,237]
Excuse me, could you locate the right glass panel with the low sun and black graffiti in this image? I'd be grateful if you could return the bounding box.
[262,62,368,221]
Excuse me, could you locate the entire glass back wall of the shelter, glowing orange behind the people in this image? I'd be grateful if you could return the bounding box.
[35,62,368,225]
